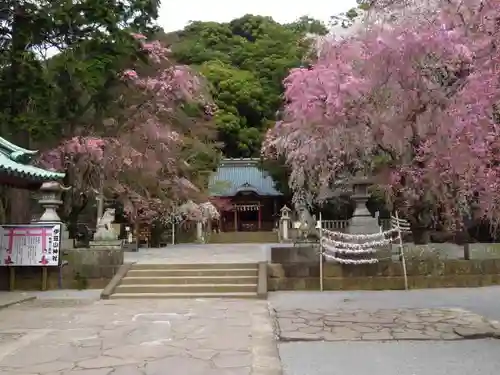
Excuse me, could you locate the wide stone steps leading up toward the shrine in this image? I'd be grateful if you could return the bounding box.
[110,263,258,299]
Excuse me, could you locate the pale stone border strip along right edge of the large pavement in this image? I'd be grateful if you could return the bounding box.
[251,302,283,375]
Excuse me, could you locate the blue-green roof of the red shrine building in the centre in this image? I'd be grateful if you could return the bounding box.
[209,159,282,197]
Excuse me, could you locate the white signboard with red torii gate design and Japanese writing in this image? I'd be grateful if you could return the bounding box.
[0,223,61,267]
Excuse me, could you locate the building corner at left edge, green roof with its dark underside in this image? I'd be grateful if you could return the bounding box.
[0,137,65,190]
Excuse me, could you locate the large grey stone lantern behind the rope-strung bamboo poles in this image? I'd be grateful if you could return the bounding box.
[348,177,379,234]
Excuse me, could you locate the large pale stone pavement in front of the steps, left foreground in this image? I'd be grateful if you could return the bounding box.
[0,298,281,375]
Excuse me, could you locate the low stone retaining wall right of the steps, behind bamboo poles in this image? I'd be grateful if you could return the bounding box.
[268,259,500,291]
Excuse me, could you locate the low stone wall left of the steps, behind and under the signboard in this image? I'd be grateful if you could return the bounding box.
[0,249,123,290]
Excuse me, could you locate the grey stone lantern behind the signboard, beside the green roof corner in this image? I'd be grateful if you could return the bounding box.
[33,181,74,250]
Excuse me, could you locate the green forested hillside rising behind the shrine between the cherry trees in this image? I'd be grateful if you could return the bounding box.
[169,15,327,157]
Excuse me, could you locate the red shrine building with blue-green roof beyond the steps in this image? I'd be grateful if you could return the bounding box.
[209,158,283,232]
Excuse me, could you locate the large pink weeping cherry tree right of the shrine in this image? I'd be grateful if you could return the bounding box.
[262,0,500,228]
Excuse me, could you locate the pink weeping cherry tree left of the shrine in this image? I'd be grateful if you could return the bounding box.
[41,35,215,221]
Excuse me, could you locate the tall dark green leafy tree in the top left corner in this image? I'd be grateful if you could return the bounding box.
[0,0,159,223]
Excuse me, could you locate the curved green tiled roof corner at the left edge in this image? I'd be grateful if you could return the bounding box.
[0,137,65,181]
